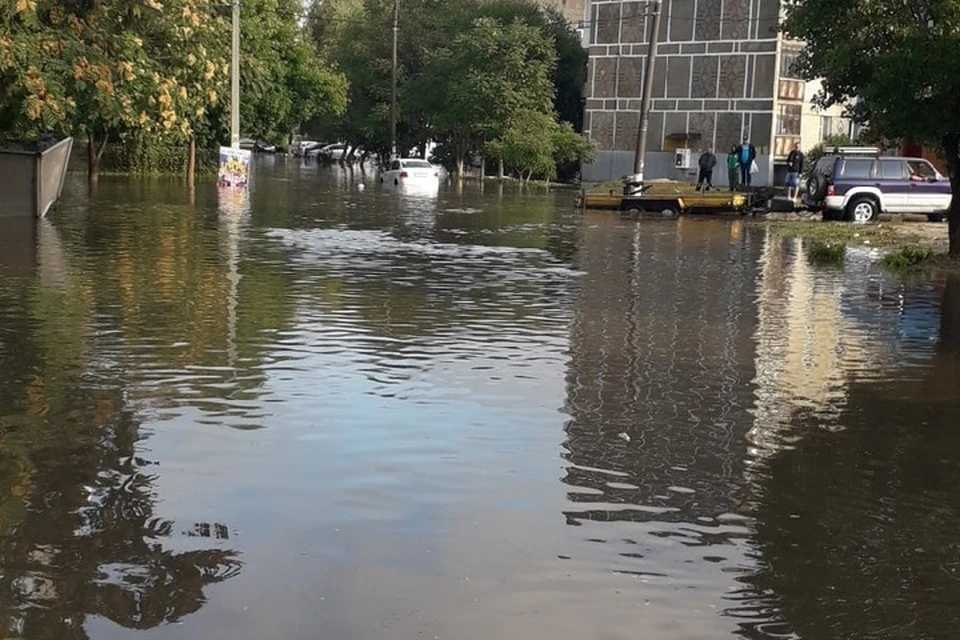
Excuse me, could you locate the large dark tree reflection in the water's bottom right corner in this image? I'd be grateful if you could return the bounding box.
[746,277,960,639]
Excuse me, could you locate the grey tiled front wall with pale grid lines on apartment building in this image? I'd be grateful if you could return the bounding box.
[585,0,780,181]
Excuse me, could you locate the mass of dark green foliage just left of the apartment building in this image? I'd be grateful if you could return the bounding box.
[309,0,590,178]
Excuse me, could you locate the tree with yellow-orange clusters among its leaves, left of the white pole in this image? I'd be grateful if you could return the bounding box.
[0,0,226,181]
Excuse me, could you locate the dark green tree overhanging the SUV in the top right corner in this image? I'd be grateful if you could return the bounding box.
[784,0,960,258]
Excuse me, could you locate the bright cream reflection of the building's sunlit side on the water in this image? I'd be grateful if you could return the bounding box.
[749,235,936,456]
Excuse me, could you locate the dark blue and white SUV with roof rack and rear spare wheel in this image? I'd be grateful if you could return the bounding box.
[804,147,951,224]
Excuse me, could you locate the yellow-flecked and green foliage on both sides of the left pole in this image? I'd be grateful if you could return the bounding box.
[0,0,346,175]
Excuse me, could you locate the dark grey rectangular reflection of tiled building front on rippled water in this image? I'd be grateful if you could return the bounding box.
[564,214,760,538]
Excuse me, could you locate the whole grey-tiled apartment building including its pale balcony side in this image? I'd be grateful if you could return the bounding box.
[581,0,849,184]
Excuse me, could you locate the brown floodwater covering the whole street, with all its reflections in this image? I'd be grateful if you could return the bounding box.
[0,158,960,640]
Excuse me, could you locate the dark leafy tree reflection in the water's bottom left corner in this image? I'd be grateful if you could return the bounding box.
[0,389,241,639]
